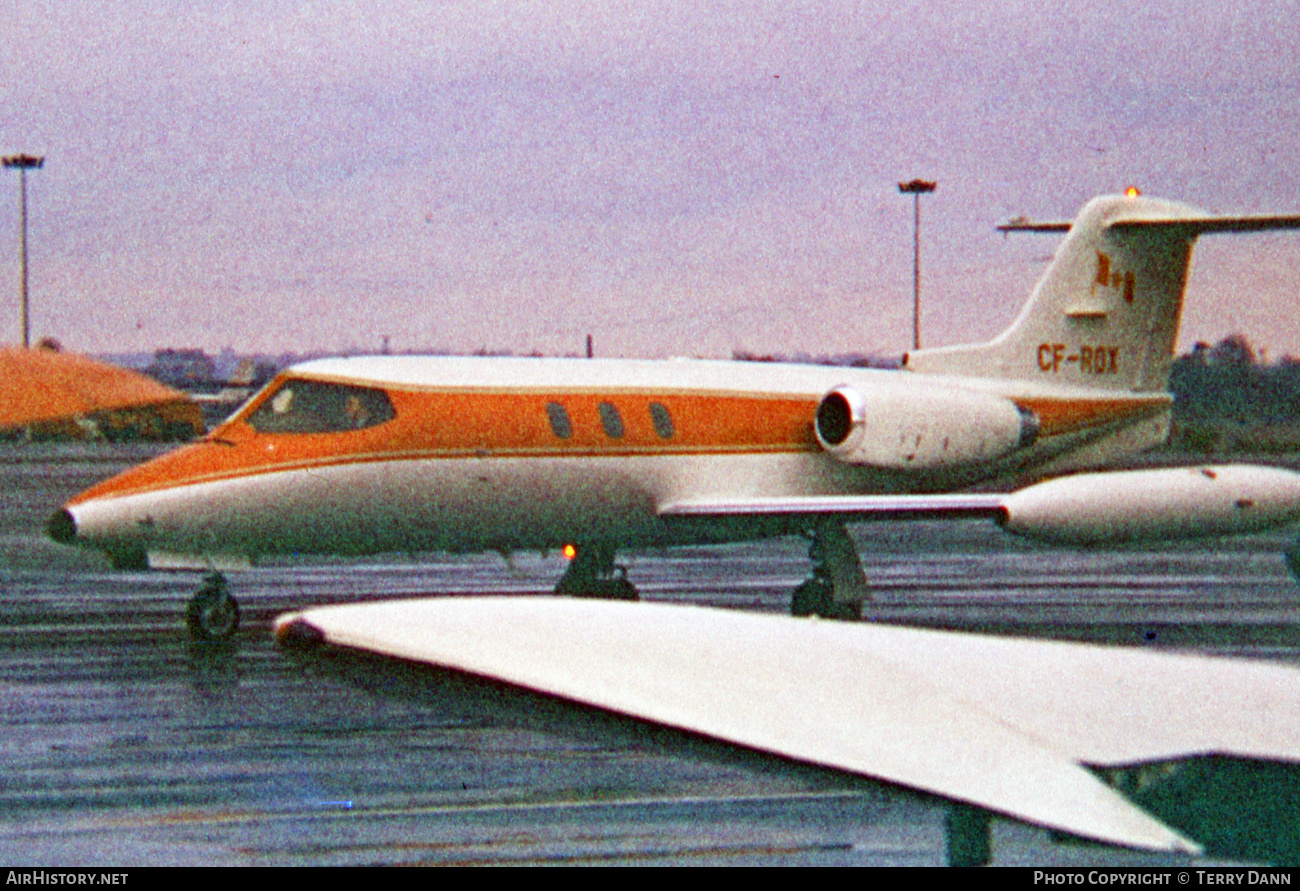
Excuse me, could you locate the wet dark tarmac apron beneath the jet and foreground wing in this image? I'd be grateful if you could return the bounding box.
[0,445,1300,868]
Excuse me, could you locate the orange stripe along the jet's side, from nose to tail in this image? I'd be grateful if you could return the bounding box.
[69,389,1167,505]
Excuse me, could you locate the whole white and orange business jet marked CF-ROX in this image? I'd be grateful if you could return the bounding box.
[49,193,1300,639]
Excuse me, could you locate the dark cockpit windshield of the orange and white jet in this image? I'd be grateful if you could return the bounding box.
[247,379,397,433]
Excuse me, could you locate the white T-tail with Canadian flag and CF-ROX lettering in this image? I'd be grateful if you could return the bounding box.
[905,194,1300,393]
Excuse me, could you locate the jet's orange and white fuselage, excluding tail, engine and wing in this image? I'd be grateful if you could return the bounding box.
[52,356,1169,567]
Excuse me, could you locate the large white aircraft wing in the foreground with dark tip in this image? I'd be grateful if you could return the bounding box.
[276,597,1300,852]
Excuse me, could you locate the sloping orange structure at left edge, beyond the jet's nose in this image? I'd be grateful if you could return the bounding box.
[0,347,203,440]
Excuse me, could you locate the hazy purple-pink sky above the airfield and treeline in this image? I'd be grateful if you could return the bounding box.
[0,0,1300,358]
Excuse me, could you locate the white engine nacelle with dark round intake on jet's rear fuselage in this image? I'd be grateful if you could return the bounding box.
[815,385,1039,471]
